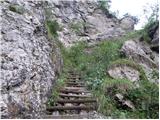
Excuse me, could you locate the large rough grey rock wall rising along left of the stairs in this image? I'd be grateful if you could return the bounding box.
[0,0,62,118]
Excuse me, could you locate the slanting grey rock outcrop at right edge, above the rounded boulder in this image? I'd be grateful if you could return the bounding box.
[121,40,159,83]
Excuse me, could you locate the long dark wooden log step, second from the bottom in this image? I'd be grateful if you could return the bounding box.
[47,106,96,111]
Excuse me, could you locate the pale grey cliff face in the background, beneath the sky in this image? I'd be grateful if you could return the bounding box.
[47,1,134,46]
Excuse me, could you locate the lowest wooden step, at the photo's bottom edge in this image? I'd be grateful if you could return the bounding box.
[43,114,89,119]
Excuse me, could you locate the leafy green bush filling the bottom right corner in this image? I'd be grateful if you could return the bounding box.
[127,81,159,119]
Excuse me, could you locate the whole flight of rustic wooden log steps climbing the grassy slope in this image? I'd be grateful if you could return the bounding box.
[45,71,97,119]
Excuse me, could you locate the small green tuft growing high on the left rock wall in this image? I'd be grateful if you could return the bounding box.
[9,5,25,14]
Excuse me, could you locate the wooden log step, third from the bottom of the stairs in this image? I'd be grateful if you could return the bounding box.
[56,99,97,103]
